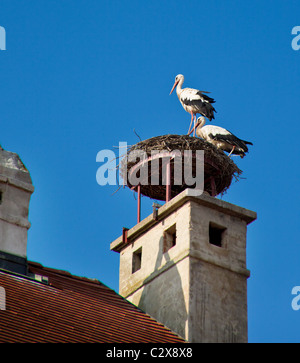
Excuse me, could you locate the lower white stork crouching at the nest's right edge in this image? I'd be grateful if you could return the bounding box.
[190,117,253,158]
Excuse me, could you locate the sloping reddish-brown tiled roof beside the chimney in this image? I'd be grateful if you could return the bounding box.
[0,262,184,343]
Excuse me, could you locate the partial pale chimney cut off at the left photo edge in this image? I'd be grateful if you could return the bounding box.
[0,147,34,275]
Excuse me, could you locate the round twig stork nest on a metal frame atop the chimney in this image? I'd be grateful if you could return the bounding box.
[119,135,242,200]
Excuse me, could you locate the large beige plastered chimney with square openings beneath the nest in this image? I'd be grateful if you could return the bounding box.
[111,189,256,343]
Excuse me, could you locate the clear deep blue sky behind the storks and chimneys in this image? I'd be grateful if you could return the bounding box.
[0,0,300,342]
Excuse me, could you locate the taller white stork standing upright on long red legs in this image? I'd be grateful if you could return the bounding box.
[170,74,217,133]
